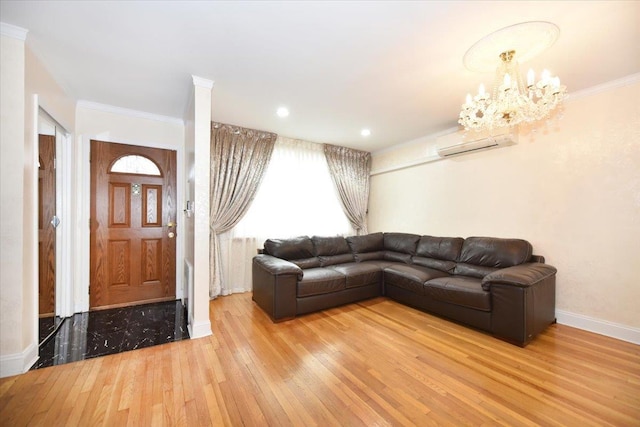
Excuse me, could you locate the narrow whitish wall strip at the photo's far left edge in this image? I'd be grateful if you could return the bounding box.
[0,24,38,377]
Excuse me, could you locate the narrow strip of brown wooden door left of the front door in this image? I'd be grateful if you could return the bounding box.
[38,135,57,317]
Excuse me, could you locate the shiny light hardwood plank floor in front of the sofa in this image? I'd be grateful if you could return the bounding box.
[0,294,640,427]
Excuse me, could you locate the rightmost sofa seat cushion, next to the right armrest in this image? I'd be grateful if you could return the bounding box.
[424,276,491,311]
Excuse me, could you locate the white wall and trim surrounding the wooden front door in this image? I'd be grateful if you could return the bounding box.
[74,101,186,312]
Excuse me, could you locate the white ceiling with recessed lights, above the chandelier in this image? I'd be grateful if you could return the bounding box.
[0,0,640,151]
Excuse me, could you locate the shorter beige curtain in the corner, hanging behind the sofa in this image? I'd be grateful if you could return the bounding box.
[324,144,371,234]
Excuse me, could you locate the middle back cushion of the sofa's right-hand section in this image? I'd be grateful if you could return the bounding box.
[412,236,464,273]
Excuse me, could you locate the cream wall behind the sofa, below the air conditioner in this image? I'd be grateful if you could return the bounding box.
[369,75,640,340]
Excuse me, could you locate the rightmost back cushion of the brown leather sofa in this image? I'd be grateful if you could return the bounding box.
[455,237,533,278]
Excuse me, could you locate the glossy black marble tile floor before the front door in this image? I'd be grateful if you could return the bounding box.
[31,300,189,370]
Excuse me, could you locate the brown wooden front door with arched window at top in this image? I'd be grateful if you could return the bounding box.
[89,141,176,309]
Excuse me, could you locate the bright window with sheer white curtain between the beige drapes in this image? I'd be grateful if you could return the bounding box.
[219,137,354,295]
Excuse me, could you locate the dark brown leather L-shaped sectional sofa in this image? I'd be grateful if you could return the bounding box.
[253,233,556,346]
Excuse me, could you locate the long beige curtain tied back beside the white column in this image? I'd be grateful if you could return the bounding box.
[209,122,277,298]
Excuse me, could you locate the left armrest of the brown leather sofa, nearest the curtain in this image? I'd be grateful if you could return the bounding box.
[252,254,302,321]
